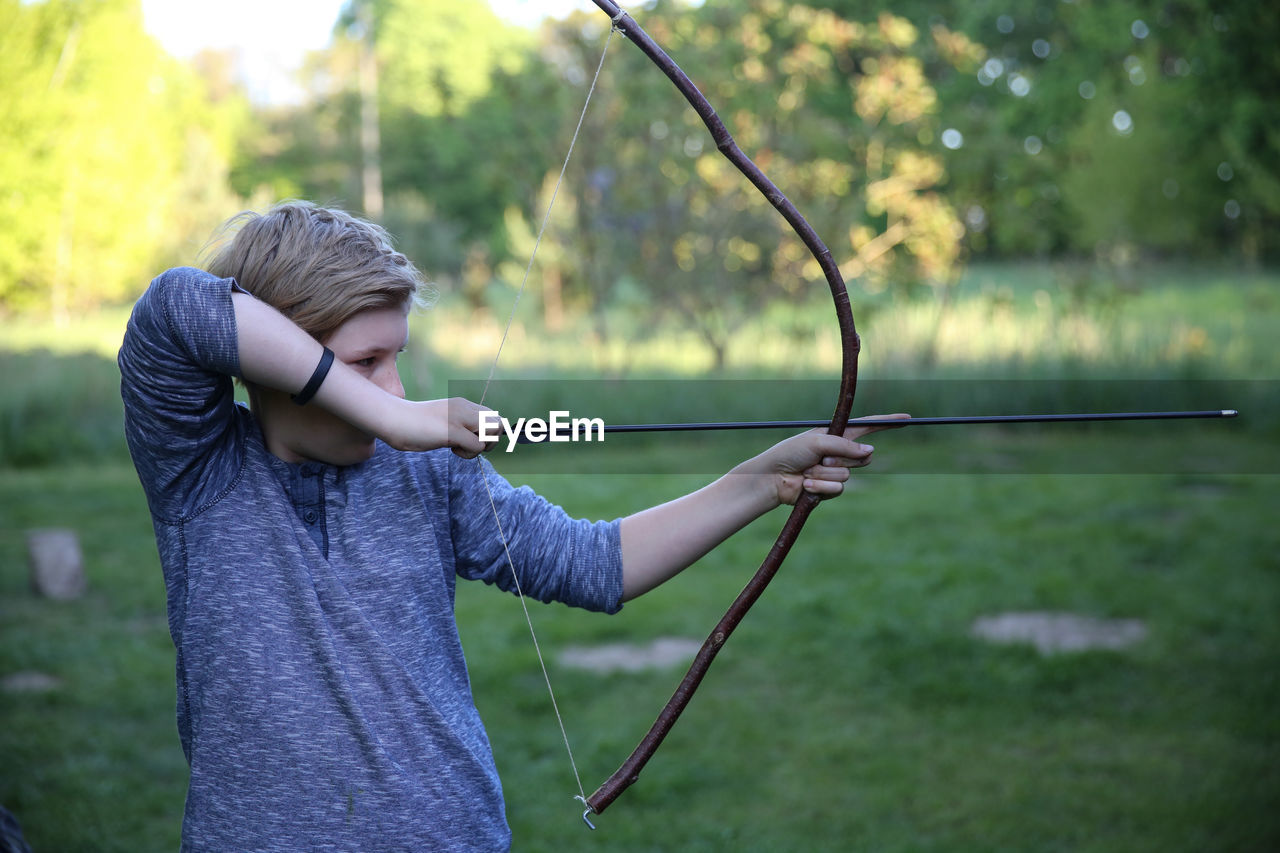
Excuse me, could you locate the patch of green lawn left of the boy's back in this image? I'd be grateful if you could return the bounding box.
[0,465,187,850]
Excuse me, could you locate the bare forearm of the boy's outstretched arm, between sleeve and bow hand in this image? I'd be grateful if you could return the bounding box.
[622,473,778,601]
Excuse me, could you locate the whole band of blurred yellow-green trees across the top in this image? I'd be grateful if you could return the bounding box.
[0,0,1280,318]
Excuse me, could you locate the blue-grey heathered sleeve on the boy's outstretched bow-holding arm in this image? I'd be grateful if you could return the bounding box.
[448,452,622,613]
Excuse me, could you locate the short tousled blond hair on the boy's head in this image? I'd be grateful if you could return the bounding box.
[206,201,435,341]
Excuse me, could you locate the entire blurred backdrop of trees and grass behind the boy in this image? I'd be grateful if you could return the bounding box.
[0,0,1280,853]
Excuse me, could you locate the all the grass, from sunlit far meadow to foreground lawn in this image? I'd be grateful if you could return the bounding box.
[0,266,1280,853]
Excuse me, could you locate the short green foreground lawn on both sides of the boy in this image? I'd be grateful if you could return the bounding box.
[0,438,1280,852]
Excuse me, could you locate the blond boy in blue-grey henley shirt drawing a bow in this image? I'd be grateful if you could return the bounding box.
[119,202,896,850]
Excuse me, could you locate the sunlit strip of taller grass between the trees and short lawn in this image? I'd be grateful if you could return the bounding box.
[0,264,1280,471]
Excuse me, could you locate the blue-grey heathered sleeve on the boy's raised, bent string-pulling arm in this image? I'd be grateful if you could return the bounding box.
[116,268,242,521]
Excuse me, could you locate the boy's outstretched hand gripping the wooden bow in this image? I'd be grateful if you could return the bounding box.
[740,414,910,505]
